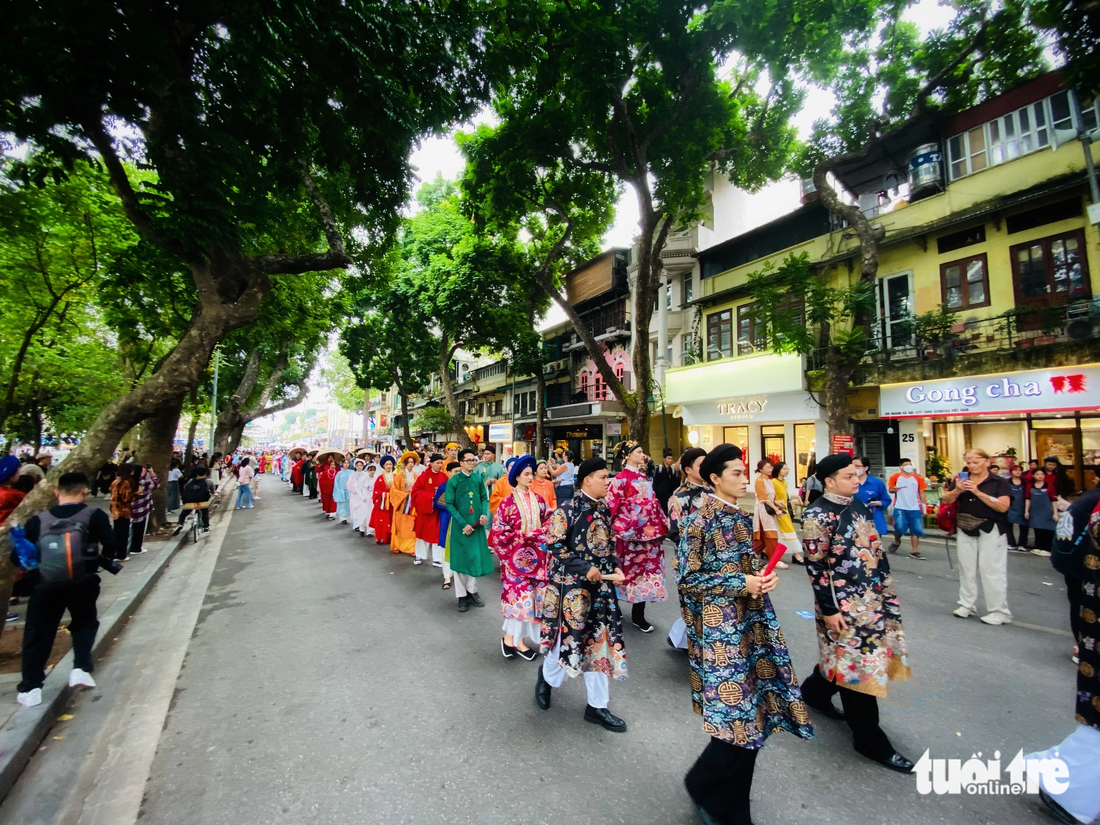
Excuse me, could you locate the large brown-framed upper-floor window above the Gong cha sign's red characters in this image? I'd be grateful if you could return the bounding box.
[1010,230,1091,307]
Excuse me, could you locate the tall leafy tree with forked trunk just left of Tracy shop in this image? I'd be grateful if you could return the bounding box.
[468,0,875,441]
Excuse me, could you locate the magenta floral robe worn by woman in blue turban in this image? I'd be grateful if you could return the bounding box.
[488,490,551,624]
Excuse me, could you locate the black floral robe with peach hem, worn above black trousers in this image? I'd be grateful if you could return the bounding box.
[802,493,910,696]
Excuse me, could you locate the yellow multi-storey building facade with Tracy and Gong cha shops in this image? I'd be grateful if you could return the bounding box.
[666,74,1100,486]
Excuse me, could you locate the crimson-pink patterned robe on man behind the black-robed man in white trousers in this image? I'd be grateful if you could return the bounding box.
[607,466,669,604]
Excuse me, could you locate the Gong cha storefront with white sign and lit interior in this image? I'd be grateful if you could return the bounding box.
[879,364,1100,490]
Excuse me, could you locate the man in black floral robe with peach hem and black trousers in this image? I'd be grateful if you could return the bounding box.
[802,453,913,773]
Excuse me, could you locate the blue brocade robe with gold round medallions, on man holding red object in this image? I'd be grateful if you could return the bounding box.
[678,495,813,749]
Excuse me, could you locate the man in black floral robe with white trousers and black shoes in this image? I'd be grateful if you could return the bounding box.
[535,458,626,733]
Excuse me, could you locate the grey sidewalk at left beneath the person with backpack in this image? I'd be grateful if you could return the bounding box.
[0,499,190,799]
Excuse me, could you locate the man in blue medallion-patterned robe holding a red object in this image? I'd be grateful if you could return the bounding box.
[678,444,814,823]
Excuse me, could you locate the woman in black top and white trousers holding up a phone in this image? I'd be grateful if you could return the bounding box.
[939,449,1007,625]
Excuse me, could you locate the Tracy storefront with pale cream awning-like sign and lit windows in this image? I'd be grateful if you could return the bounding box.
[666,354,828,486]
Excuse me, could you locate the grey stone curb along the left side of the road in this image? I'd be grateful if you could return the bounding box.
[0,530,190,801]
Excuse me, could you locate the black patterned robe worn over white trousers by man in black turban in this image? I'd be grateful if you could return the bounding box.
[540,493,626,679]
